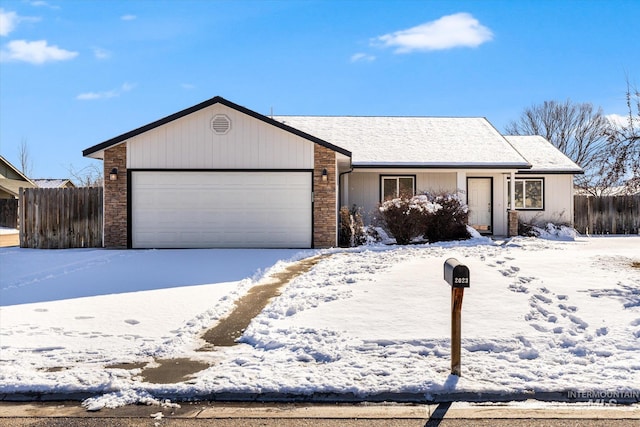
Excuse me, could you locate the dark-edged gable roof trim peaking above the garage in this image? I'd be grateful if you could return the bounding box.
[82,96,351,159]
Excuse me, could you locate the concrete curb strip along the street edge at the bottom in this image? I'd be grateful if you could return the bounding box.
[0,402,640,420]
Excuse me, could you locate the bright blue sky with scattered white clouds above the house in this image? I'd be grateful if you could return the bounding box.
[0,0,640,178]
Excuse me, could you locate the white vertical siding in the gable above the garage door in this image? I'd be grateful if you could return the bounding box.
[127,104,313,169]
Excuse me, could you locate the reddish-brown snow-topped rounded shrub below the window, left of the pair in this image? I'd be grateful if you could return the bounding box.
[378,194,442,245]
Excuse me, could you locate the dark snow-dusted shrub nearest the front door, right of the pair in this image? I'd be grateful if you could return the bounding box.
[423,192,471,242]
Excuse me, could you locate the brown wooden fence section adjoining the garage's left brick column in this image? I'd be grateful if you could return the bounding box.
[20,187,102,249]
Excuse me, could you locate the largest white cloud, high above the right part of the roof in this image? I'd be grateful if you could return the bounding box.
[374,13,493,53]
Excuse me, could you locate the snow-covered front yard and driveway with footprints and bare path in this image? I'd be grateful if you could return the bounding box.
[0,236,640,407]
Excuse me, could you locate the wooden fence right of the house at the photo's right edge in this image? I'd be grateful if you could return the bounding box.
[574,194,640,234]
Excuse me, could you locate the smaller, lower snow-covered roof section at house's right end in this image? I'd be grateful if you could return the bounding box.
[505,135,584,174]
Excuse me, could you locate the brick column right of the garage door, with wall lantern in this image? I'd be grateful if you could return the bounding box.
[313,144,338,248]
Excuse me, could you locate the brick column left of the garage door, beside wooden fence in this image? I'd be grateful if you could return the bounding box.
[104,143,127,248]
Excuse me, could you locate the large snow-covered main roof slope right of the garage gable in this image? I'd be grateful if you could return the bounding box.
[274,116,529,168]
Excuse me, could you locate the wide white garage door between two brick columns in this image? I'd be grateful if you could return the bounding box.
[131,171,312,248]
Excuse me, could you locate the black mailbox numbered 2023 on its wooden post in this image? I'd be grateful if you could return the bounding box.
[444,258,471,376]
